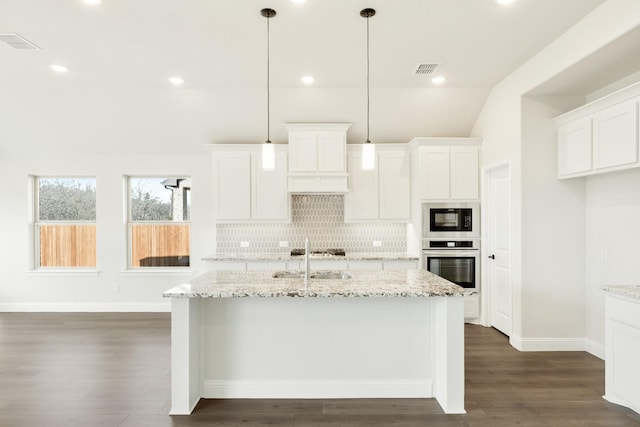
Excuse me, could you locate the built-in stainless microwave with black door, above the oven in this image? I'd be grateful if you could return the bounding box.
[422,203,480,239]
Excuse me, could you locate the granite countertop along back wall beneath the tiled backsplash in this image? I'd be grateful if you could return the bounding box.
[202,252,419,261]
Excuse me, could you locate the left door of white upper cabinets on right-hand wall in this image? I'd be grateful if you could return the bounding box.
[558,117,591,176]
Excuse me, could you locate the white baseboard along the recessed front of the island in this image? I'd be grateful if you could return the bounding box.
[202,380,433,399]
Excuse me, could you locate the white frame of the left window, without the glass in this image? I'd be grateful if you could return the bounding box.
[29,174,98,270]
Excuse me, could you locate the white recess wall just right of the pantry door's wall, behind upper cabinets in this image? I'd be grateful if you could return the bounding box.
[519,97,585,350]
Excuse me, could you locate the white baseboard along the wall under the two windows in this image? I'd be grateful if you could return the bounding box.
[0,302,171,313]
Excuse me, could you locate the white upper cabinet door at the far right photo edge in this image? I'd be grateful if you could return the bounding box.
[593,99,638,169]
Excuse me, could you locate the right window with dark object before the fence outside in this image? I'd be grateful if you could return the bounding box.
[127,177,191,268]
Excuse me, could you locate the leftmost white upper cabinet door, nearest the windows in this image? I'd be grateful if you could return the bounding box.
[212,152,251,220]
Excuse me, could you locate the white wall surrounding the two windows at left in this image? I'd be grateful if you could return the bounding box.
[0,152,215,311]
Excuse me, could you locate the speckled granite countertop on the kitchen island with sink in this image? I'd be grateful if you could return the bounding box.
[163,270,464,298]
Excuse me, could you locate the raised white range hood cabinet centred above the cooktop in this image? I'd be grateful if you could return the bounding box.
[286,123,351,193]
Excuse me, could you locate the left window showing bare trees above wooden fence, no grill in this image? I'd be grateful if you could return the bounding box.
[34,177,96,268]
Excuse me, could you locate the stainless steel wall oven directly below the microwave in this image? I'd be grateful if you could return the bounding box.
[423,239,480,291]
